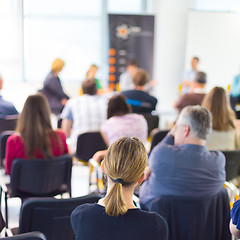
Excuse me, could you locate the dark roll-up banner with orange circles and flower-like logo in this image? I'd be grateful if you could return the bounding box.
[108,14,154,90]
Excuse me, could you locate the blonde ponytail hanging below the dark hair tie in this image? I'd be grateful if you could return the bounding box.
[104,182,128,217]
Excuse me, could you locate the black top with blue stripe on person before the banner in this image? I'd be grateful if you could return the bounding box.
[122,90,157,113]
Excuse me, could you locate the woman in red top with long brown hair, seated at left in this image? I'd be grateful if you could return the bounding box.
[6,93,68,175]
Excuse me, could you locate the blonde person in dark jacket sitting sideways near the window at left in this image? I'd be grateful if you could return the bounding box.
[40,58,69,115]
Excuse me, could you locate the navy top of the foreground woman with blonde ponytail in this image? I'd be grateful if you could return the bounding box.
[71,203,168,240]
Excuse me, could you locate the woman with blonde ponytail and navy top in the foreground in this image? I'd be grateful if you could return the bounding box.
[71,137,168,240]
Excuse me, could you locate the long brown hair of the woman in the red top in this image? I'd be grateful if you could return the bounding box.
[16,93,63,158]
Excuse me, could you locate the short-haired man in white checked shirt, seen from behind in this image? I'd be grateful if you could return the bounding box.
[61,79,107,151]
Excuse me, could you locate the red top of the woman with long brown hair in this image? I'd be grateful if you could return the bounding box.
[5,130,68,175]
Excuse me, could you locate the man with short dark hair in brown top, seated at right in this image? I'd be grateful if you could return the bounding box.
[174,72,207,112]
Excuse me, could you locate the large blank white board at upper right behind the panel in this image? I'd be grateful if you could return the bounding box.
[185,11,240,90]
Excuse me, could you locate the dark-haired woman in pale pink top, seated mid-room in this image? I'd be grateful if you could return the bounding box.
[101,94,148,146]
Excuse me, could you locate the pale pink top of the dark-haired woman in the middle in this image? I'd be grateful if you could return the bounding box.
[101,113,148,146]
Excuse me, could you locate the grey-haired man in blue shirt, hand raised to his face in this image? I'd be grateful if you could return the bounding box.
[140,106,226,209]
